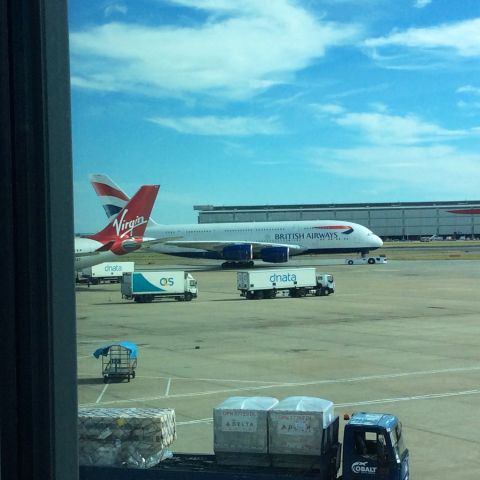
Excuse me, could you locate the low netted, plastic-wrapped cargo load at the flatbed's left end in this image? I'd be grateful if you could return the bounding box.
[78,408,176,468]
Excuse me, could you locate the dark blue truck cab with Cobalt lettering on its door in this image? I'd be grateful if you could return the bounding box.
[342,412,410,480]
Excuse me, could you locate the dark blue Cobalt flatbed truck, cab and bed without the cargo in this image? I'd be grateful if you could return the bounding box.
[80,412,410,480]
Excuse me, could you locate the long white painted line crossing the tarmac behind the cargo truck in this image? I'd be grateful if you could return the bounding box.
[81,366,480,406]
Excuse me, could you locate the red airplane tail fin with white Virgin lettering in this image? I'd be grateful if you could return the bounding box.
[88,185,160,254]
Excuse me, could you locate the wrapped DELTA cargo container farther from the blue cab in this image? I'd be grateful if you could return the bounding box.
[213,397,278,466]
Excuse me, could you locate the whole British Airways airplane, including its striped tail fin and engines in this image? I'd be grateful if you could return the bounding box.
[90,174,383,268]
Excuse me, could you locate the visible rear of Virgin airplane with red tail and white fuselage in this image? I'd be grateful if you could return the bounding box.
[75,185,160,270]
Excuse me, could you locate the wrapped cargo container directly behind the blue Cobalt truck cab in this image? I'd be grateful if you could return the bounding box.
[268,397,335,468]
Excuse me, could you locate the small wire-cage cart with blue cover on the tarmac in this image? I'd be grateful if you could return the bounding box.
[93,342,137,383]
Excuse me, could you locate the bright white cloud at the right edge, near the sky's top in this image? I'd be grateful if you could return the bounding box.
[363,18,480,62]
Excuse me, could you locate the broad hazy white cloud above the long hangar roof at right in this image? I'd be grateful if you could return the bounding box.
[310,106,480,198]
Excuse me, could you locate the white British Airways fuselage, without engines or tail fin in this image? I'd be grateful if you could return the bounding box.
[145,220,383,258]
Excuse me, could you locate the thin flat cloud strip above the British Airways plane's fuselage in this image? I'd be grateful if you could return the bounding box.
[149,116,284,137]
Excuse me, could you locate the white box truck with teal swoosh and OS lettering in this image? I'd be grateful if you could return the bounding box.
[121,270,198,303]
